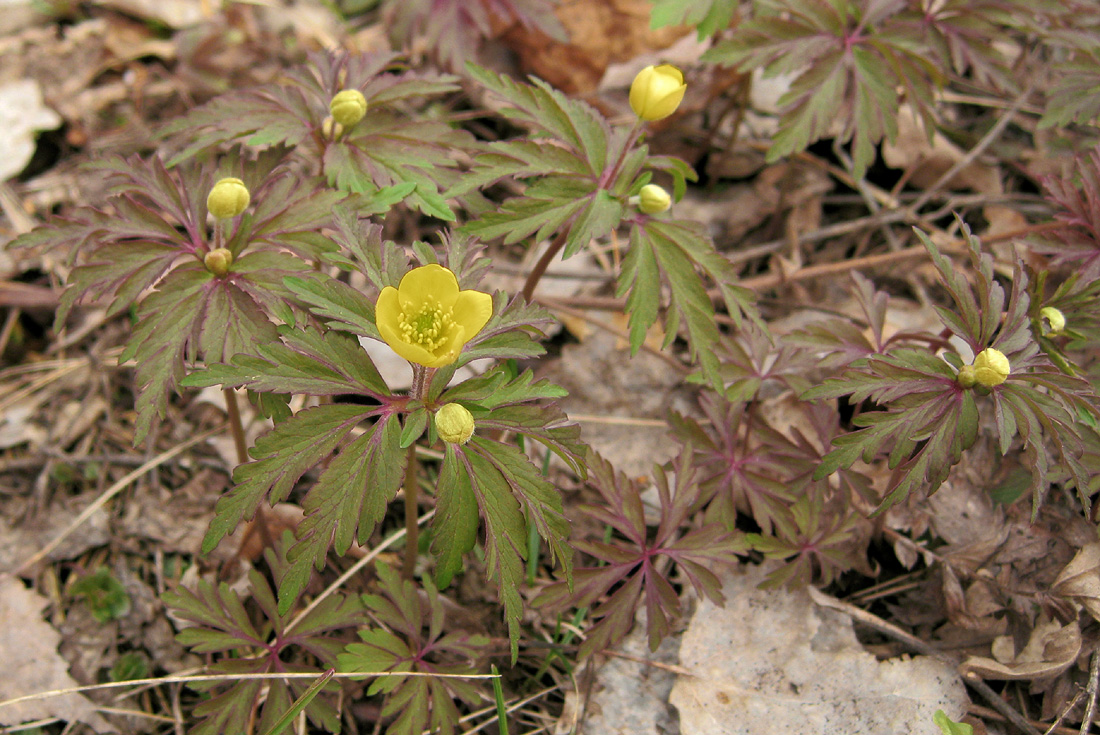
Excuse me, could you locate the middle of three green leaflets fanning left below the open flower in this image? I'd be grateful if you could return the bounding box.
[202,404,375,553]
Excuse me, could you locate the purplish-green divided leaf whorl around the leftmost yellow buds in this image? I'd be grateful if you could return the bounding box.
[14,154,343,443]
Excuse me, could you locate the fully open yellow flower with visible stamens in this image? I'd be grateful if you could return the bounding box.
[375,263,493,368]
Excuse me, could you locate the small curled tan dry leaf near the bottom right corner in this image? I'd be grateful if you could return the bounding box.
[959,621,1081,681]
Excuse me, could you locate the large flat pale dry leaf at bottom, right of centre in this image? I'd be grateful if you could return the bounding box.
[672,567,967,735]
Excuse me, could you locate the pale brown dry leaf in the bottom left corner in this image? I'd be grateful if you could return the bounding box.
[0,574,114,733]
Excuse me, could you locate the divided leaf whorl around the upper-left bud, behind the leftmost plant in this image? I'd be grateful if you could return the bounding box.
[164,54,472,220]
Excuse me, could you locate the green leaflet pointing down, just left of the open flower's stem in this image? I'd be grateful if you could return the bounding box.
[276,414,406,614]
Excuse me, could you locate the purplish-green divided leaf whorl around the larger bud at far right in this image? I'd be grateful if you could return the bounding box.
[803,220,1100,513]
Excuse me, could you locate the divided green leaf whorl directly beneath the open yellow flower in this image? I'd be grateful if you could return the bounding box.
[186,239,584,646]
